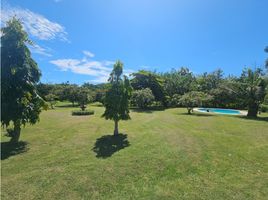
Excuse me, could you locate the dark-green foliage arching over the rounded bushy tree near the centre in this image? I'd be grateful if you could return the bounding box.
[131,70,166,106]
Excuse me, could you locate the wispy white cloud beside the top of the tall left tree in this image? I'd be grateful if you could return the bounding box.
[1,3,68,41]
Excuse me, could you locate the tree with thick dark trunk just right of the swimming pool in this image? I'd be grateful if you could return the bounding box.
[239,68,266,117]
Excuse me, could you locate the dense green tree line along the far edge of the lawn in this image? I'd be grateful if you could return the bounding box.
[37,67,268,116]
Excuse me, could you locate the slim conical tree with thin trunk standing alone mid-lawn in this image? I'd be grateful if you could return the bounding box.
[102,61,131,135]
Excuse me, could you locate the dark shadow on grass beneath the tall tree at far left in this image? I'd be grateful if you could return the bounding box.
[1,141,28,160]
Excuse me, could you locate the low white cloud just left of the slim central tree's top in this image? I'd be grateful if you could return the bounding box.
[50,52,133,83]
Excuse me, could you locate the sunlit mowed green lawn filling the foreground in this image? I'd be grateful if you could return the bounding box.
[1,106,268,200]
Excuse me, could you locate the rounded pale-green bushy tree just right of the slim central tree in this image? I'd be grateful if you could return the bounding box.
[132,88,154,109]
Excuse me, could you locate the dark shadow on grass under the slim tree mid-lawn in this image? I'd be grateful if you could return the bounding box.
[92,133,130,158]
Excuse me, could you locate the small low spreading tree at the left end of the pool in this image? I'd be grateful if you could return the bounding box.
[180,91,211,114]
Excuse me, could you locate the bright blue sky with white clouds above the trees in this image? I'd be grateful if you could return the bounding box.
[1,0,268,84]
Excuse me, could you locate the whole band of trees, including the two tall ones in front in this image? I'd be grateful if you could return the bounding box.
[1,18,268,143]
